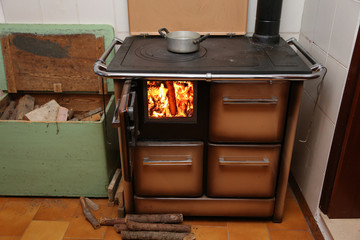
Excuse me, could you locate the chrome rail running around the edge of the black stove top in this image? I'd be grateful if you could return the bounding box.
[93,38,326,82]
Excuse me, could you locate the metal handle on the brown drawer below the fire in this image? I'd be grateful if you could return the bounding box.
[143,155,192,166]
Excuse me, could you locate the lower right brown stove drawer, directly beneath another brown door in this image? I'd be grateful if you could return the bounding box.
[207,144,281,197]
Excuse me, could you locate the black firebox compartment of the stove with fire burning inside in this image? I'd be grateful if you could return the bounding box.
[133,79,209,140]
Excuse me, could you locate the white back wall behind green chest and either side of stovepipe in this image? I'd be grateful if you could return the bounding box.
[0,0,305,38]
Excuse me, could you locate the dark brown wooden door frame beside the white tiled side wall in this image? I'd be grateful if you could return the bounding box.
[320,26,360,214]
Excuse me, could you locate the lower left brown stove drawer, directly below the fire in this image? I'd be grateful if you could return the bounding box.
[134,142,204,197]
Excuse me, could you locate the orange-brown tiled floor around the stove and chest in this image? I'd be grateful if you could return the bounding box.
[0,190,313,240]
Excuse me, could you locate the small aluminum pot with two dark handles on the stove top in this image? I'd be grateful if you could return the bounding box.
[159,28,210,53]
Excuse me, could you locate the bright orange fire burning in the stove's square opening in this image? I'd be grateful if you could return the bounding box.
[147,81,194,118]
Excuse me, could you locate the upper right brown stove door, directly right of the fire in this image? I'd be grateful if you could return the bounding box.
[209,81,290,143]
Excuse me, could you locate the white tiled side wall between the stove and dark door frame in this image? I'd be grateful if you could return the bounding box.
[292,0,360,229]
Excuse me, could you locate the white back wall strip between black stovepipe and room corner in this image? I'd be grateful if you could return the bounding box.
[280,0,305,33]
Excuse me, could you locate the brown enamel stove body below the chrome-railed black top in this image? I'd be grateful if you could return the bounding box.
[115,79,302,221]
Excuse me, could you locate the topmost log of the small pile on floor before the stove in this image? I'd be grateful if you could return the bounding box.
[126,213,184,223]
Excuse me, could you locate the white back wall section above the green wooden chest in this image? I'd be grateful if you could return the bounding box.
[0,0,129,38]
